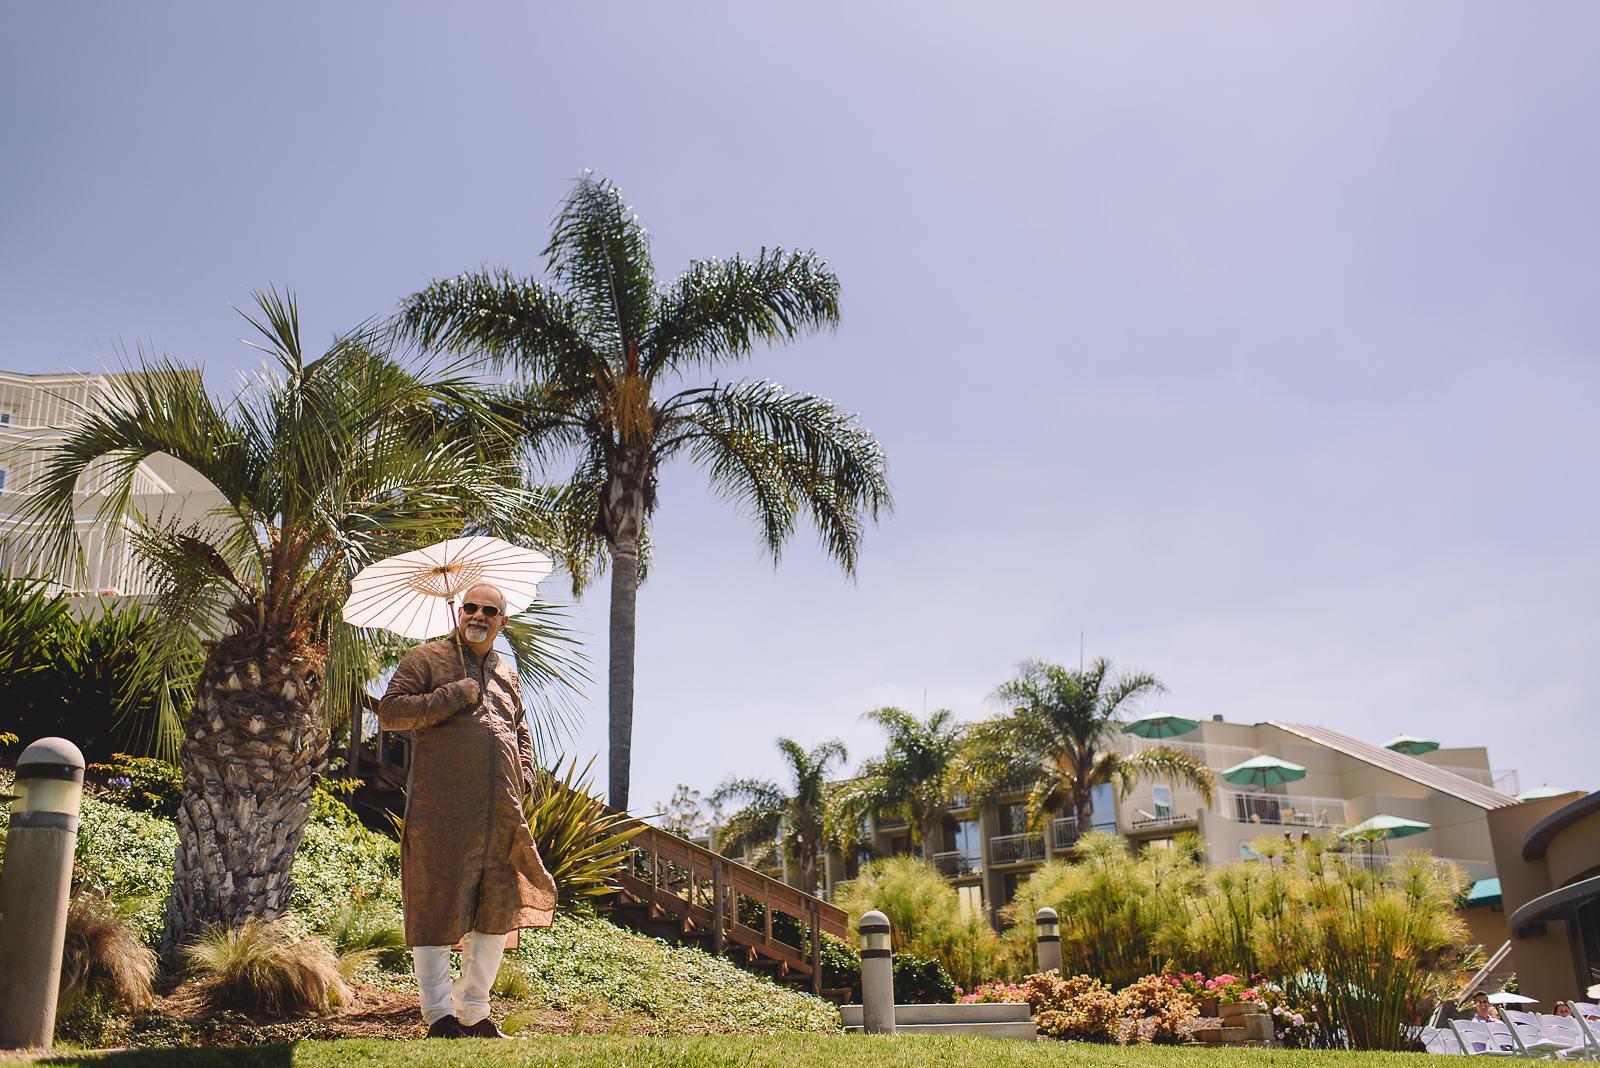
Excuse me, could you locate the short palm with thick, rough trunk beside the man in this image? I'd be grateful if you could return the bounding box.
[29,291,576,953]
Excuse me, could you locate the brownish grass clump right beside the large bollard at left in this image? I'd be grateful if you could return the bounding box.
[56,892,155,1017]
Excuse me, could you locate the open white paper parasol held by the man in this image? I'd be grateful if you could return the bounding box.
[342,536,554,638]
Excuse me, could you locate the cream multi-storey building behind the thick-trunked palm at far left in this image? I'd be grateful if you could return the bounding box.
[0,371,224,604]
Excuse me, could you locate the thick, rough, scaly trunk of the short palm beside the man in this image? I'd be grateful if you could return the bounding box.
[162,635,328,959]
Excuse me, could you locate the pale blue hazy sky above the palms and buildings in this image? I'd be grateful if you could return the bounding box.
[0,3,1600,806]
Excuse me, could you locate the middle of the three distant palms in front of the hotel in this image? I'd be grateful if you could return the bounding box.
[829,708,965,859]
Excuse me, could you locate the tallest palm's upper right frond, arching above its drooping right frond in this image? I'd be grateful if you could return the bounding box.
[643,248,838,379]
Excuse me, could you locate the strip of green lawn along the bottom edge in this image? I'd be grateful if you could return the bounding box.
[42,1034,1424,1068]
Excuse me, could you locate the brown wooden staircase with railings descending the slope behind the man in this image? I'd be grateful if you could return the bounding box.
[344,724,850,994]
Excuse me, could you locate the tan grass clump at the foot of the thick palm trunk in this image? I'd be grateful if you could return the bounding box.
[182,919,349,1017]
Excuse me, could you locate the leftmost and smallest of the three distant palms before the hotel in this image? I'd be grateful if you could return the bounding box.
[710,739,848,894]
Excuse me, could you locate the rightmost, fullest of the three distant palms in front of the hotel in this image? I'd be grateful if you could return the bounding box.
[968,659,1213,830]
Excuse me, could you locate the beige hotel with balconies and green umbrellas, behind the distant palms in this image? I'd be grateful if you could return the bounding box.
[824,716,1518,946]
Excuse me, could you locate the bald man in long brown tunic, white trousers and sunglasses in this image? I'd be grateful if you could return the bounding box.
[378,585,555,1038]
